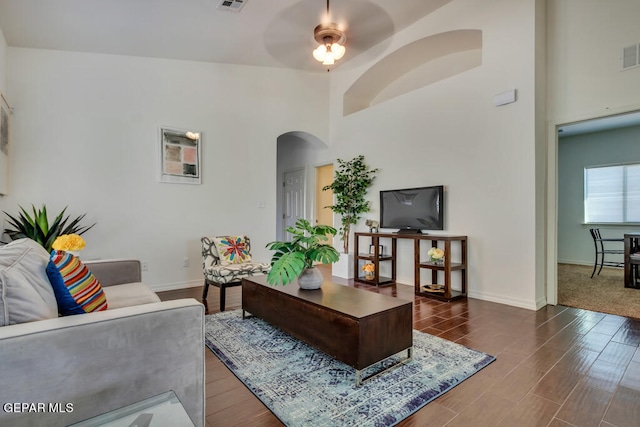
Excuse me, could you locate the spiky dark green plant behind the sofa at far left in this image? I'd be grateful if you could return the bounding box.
[3,204,96,252]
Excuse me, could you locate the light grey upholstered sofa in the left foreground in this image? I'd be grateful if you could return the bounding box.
[0,239,205,427]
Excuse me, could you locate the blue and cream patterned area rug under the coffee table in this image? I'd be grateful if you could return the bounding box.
[205,310,495,427]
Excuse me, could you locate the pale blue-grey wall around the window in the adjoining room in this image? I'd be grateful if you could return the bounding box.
[558,126,640,265]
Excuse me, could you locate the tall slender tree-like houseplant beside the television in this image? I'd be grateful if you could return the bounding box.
[322,155,379,254]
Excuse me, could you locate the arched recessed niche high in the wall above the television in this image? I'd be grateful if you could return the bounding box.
[343,30,482,116]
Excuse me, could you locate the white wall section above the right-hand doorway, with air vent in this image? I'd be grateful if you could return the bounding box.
[547,0,640,122]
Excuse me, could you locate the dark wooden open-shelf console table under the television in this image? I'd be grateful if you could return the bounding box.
[353,233,467,301]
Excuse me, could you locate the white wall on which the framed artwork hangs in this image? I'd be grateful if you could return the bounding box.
[5,48,328,290]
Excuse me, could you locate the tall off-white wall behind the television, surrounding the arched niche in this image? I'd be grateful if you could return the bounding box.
[318,0,544,308]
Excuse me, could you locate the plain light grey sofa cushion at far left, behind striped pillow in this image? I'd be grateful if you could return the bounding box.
[0,239,58,326]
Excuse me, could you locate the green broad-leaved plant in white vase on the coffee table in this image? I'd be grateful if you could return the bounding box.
[267,218,340,285]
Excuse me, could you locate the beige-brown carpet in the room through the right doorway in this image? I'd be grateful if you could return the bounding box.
[558,264,640,319]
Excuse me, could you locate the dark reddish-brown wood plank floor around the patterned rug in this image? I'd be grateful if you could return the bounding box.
[160,270,640,427]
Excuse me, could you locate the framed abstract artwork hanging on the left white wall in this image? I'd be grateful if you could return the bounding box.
[158,126,202,184]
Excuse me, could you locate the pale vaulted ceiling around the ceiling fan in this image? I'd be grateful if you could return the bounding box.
[0,0,451,71]
